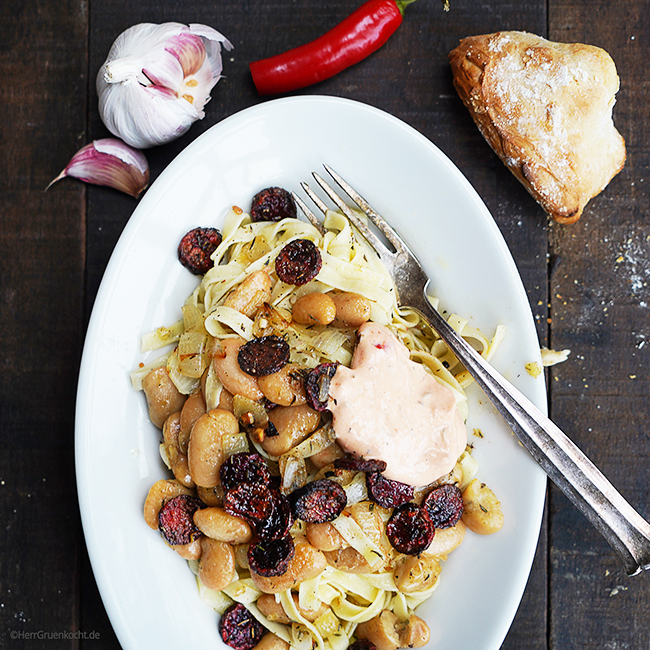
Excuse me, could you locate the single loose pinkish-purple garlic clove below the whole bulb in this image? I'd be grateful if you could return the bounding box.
[45,138,149,199]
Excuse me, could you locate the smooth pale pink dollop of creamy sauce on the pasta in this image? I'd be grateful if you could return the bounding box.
[329,323,467,486]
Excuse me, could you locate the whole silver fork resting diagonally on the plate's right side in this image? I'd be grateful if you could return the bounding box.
[294,165,650,576]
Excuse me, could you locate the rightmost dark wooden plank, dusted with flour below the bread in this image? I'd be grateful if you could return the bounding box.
[549,0,650,650]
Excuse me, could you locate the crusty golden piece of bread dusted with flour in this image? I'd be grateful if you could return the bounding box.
[449,32,625,224]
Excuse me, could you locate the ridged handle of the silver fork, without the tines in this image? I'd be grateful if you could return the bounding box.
[415,296,650,576]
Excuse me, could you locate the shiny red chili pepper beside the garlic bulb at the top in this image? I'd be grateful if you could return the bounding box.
[249,0,414,95]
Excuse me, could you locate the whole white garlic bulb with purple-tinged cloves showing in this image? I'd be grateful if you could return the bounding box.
[97,23,232,149]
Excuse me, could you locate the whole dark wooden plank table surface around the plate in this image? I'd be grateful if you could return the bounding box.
[0,0,650,650]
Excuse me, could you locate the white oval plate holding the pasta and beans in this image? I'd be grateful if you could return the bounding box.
[76,97,546,650]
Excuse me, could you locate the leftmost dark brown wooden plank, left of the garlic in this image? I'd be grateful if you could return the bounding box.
[0,0,87,648]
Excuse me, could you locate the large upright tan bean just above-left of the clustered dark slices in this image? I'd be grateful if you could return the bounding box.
[187,409,239,487]
